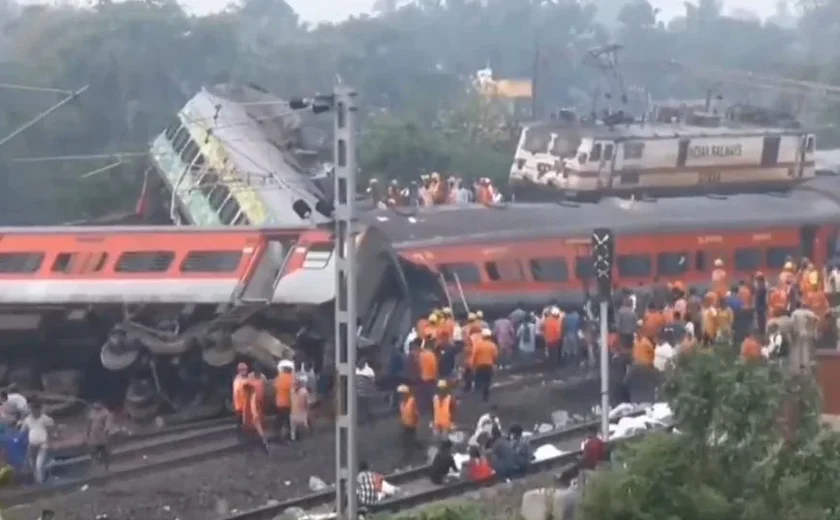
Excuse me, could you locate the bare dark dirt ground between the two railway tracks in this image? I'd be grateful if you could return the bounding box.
[4,370,599,520]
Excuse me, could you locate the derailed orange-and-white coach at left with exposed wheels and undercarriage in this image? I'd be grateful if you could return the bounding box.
[0,226,411,415]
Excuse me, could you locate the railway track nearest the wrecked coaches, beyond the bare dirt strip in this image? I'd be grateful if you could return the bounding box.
[0,364,593,507]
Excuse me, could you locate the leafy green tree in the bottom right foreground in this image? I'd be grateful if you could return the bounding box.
[583,349,840,520]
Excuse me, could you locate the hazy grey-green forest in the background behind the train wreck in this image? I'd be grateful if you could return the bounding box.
[0,0,840,223]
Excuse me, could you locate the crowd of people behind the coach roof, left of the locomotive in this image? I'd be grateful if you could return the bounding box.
[367,172,503,208]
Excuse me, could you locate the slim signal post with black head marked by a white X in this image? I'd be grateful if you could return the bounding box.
[592,228,615,442]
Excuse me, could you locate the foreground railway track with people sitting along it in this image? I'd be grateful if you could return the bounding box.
[218,421,612,520]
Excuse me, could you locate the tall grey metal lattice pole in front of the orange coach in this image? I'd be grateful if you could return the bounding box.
[333,85,359,520]
